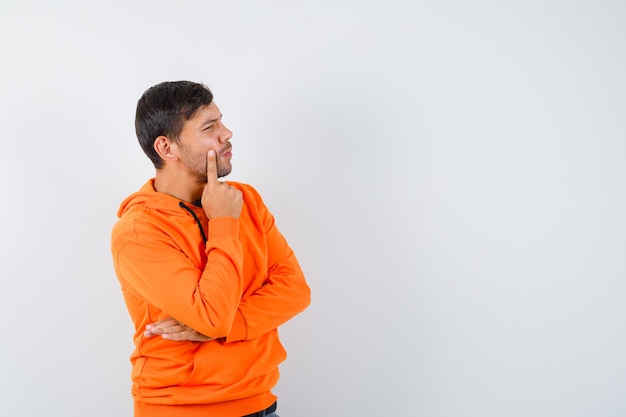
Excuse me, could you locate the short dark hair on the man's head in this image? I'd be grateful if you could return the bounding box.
[135,81,213,169]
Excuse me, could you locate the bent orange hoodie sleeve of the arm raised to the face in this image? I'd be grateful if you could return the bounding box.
[113,217,243,338]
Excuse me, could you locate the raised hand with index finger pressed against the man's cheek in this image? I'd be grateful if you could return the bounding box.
[202,149,243,219]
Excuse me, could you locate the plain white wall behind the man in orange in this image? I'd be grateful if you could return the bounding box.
[0,0,626,417]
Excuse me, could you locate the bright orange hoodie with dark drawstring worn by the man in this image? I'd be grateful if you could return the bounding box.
[111,179,310,417]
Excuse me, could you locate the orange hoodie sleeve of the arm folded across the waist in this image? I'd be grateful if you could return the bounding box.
[226,185,311,342]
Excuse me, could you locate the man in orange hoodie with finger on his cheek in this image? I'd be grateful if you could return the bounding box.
[112,81,310,417]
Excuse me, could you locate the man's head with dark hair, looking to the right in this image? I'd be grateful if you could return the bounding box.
[135,81,232,182]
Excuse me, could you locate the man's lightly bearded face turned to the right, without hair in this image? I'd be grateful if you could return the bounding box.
[178,102,233,184]
